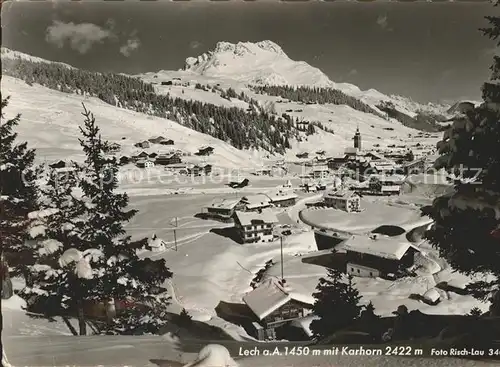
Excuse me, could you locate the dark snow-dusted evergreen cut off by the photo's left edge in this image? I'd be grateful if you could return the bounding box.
[0,97,40,282]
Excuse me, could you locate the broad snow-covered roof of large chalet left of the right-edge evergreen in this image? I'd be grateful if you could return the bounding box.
[342,236,420,260]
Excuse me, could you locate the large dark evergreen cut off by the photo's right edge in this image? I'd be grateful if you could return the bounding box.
[423,12,500,315]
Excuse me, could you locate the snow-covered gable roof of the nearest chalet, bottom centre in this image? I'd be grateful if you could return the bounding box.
[243,277,309,320]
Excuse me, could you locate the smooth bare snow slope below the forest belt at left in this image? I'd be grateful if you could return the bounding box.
[2,76,259,167]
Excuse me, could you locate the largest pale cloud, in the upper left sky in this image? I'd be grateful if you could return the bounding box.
[45,20,116,54]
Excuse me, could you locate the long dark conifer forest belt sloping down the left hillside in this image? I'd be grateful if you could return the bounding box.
[2,58,299,153]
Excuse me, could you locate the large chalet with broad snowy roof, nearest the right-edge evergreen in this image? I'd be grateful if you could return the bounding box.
[342,234,420,277]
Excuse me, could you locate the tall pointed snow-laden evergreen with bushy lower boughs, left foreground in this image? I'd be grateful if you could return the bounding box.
[20,106,172,335]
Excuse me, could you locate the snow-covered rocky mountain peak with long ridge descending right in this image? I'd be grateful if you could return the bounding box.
[183,40,449,117]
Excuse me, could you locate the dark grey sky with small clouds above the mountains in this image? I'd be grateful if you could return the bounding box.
[2,1,500,102]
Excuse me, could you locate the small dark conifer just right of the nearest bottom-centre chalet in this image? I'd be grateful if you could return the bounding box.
[310,269,363,338]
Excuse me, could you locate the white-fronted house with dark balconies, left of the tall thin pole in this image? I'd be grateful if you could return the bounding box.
[233,210,278,243]
